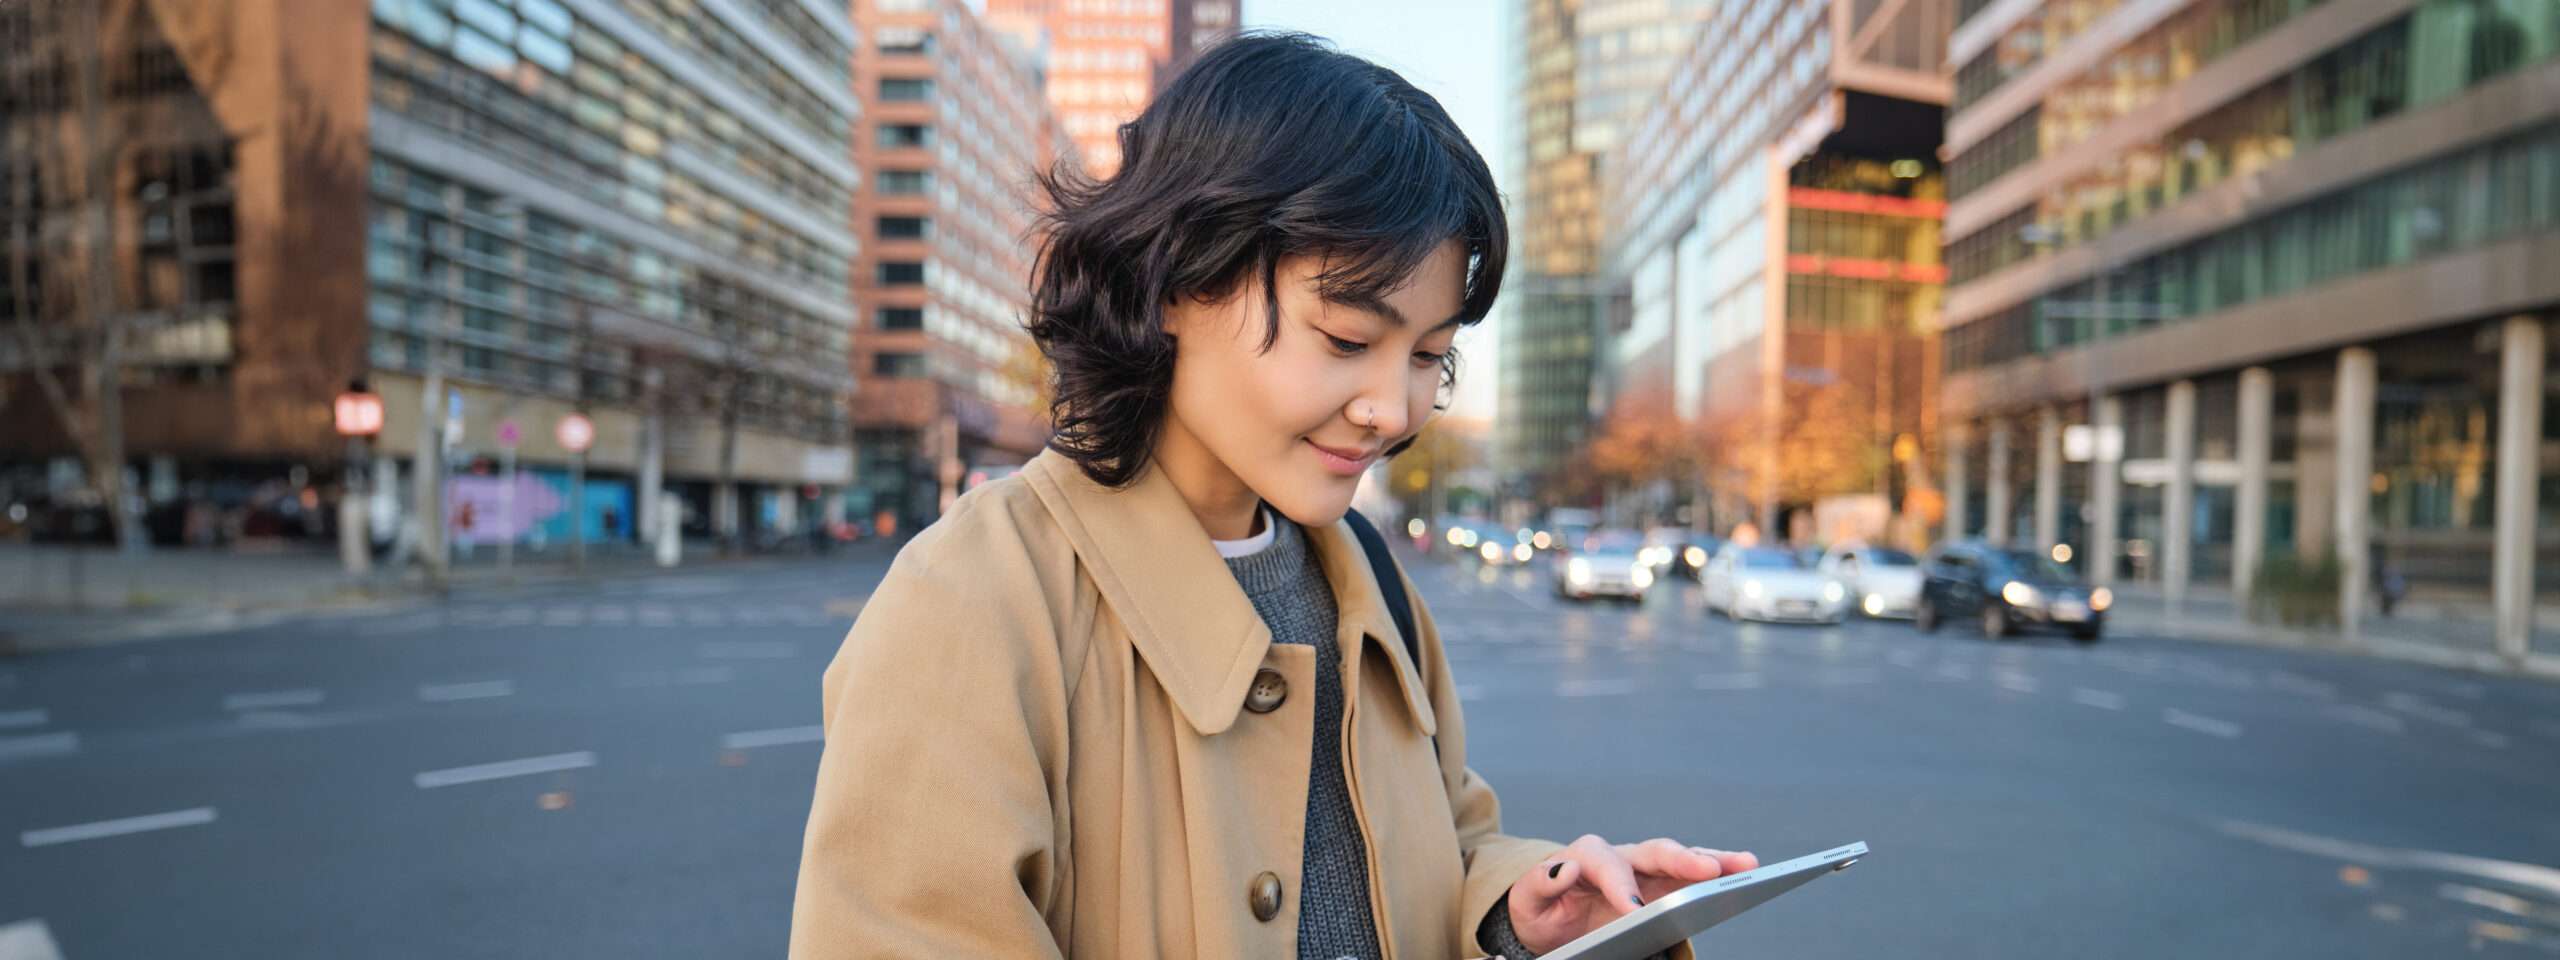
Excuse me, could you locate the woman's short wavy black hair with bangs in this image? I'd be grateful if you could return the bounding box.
[1027,31,1510,486]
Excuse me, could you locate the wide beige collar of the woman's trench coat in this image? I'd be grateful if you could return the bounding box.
[1021,451,1439,735]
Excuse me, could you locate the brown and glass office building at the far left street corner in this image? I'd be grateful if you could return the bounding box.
[0,0,860,545]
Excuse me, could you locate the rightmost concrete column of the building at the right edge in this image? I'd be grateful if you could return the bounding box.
[2491,317,2542,666]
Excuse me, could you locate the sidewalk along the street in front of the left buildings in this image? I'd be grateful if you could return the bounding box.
[0,543,893,658]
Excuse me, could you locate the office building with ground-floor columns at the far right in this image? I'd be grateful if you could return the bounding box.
[1943,0,2560,658]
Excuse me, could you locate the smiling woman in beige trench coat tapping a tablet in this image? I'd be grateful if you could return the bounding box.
[791,36,1756,960]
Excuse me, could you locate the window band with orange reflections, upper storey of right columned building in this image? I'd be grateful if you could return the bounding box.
[1948,0,2560,284]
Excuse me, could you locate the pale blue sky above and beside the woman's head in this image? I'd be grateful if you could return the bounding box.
[1244,0,1513,420]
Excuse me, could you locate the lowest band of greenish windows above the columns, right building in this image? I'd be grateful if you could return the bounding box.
[1946,125,2560,371]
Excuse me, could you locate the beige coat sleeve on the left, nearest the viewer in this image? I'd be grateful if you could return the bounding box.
[791,535,1065,960]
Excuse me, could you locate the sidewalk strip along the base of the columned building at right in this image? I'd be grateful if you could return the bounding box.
[2107,584,2560,678]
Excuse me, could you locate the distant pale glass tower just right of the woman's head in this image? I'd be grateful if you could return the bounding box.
[1495,0,1710,489]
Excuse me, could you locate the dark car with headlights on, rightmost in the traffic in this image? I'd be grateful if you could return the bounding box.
[1912,540,2115,643]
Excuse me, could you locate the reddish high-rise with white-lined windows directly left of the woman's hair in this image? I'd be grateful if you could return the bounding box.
[852,0,1075,535]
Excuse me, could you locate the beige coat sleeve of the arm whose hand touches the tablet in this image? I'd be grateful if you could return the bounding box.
[1398,573,1692,960]
